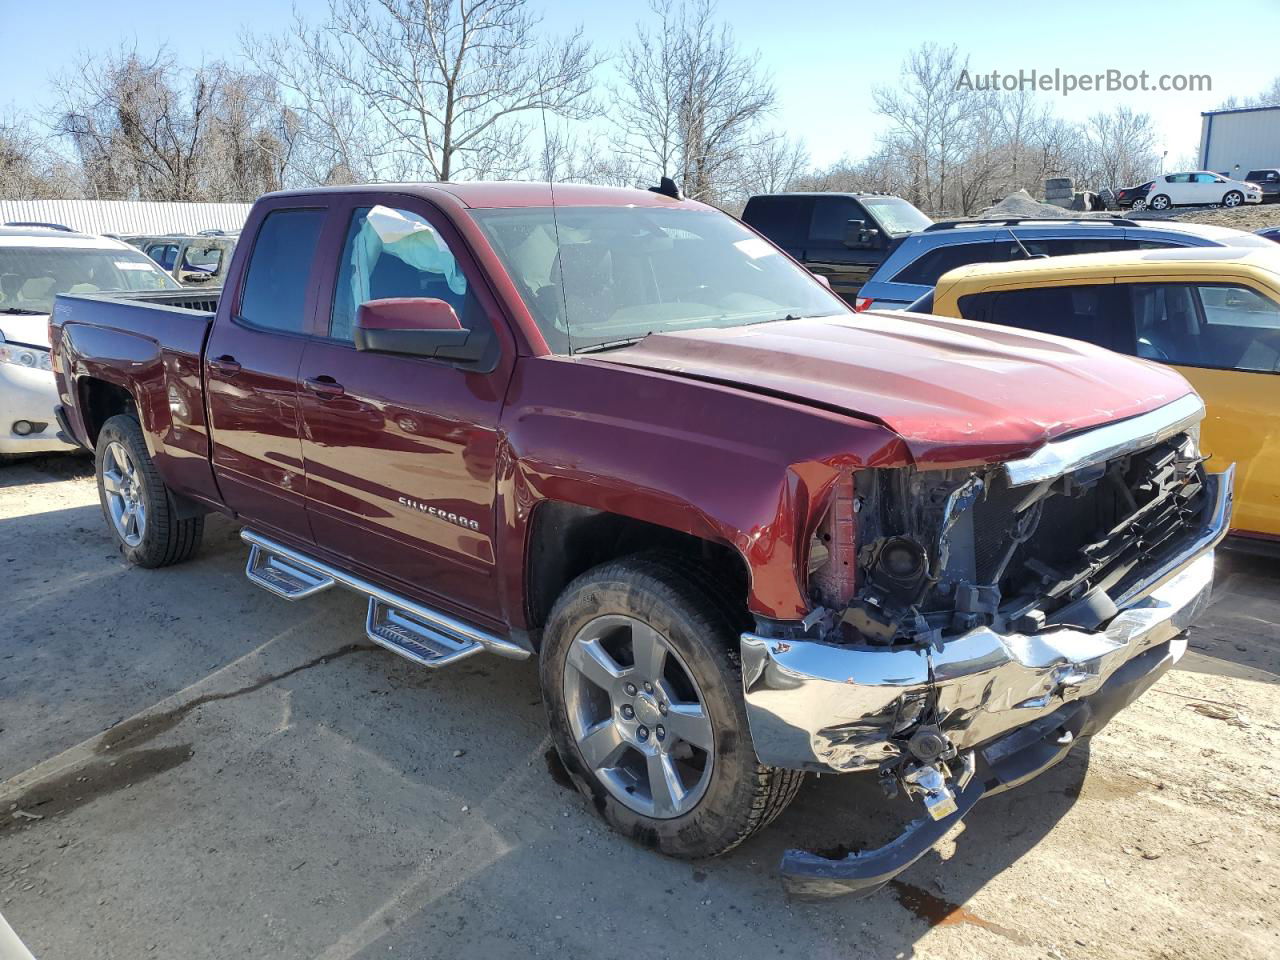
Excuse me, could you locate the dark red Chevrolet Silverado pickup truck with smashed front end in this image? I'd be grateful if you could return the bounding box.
[51,183,1231,896]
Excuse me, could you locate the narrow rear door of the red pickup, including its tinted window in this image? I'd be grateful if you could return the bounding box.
[205,200,328,541]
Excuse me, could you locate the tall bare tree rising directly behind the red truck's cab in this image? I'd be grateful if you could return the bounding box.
[244,0,599,180]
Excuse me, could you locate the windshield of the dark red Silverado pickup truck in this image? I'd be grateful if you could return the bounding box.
[471,206,850,353]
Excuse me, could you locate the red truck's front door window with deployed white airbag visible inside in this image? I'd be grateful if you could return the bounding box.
[329,206,489,340]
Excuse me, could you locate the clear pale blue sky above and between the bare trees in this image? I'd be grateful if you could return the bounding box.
[0,0,1280,164]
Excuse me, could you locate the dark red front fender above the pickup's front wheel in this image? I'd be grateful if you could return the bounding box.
[498,356,909,620]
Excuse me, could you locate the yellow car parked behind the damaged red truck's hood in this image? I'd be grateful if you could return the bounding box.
[918,247,1280,541]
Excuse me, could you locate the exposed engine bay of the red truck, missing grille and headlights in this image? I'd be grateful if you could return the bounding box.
[809,433,1204,646]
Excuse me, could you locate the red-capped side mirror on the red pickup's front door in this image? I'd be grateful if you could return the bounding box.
[353,297,486,364]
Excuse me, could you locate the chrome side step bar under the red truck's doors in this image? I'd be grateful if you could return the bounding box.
[241,527,529,668]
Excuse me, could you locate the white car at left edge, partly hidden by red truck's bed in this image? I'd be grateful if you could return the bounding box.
[0,227,182,458]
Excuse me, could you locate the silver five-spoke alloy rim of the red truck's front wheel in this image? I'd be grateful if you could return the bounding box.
[564,614,716,819]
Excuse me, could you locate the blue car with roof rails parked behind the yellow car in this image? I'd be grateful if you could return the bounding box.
[854,218,1268,310]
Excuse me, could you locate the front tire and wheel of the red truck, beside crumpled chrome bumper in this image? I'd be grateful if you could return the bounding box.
[540,553,804,859]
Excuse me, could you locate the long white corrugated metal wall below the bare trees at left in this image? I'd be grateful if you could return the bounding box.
[0,200,252,236]
